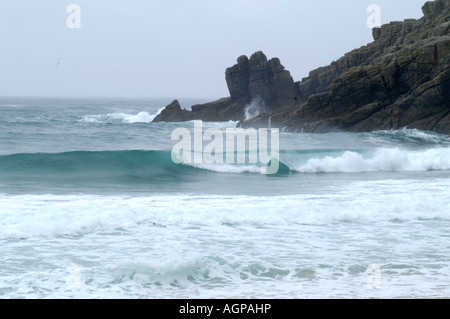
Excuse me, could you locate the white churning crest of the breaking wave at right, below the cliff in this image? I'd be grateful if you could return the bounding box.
[295,148,450,173]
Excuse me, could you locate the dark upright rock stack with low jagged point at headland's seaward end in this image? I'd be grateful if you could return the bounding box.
[153,51,297,122]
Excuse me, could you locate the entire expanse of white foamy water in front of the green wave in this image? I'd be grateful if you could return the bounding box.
[0,179,450,298]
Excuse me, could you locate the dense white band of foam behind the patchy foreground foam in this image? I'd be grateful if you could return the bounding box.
[0,179,450,238]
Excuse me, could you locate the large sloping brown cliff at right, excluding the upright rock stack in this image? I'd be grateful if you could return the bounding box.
[243,0,450,134]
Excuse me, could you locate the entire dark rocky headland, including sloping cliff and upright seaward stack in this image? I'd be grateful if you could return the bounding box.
[155,0,450,133]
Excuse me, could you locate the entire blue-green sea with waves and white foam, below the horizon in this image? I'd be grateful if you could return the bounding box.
[0,98,450,299]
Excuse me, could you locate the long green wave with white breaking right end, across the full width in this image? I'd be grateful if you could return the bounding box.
[0,148,450,180]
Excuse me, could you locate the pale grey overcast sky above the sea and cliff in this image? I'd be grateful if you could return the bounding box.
[0,0,425,98]
